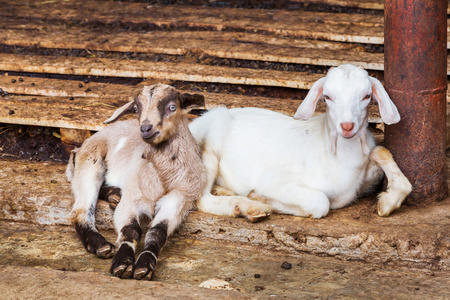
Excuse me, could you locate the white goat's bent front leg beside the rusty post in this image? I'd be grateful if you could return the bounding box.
[370,146,412,217]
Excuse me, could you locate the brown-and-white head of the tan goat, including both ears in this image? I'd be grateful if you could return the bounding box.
[104,84,205,145]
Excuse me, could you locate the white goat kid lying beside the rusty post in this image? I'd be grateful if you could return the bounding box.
[189,65,412,222]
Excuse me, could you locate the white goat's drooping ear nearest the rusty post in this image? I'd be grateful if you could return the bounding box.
[369,76,400,125]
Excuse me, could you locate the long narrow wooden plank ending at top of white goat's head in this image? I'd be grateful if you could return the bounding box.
[0,54,323,89]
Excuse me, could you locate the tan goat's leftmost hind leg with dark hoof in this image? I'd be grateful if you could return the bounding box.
[70,151,115,258]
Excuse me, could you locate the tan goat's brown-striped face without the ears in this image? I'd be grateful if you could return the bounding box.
[135,85,182,145]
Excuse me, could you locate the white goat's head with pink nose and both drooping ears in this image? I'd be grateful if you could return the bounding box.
[294,64,400,139]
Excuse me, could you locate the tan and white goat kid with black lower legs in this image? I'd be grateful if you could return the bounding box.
[66,84,206,280]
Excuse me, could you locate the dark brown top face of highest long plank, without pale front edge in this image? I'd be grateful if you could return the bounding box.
[0,0,383,28]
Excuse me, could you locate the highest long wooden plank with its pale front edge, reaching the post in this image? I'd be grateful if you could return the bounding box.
[0,1,383,44]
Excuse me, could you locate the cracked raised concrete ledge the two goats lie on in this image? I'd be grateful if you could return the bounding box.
[0,160,450,271]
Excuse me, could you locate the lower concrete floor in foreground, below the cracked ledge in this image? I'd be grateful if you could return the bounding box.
[0,221,450,299]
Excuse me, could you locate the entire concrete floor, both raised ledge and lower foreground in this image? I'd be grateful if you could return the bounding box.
[0,159,450,299]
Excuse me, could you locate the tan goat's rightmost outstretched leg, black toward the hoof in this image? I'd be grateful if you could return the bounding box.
[134,191,193,280]
